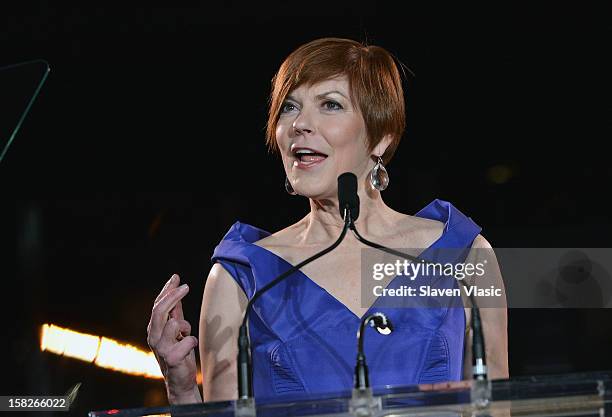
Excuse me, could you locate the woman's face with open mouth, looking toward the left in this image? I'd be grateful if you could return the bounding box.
[276,76,370,199]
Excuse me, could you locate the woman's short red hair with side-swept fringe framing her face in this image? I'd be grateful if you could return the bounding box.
[266,38,406,163]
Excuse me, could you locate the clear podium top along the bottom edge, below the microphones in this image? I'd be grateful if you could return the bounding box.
[89,371,612,417]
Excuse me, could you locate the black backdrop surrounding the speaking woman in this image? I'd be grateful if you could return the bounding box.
[0,1,612,413]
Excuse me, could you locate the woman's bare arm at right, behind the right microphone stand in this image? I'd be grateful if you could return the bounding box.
[462,235,509,379]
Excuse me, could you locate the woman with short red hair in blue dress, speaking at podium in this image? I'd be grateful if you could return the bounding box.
[148,38,508,404]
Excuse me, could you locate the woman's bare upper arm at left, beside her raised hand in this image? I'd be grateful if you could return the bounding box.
[199,263,248,402]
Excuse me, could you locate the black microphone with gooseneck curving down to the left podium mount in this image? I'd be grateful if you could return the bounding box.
[237,173,359,407]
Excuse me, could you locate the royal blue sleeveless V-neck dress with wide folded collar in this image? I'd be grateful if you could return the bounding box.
[212,199,481,400]
